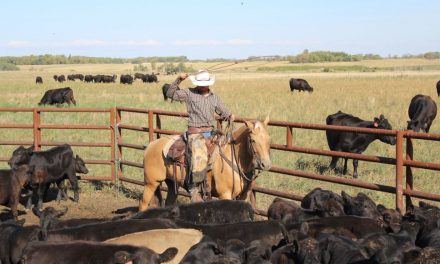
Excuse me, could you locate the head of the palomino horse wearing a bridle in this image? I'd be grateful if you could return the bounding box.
[244,116,272,170]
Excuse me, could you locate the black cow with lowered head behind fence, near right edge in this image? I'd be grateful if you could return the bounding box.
[407,94,437,133]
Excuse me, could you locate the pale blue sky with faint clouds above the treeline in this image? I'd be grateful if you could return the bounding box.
[0,0,440,59]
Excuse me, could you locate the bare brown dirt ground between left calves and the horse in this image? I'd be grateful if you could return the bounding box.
[0,182,144,225]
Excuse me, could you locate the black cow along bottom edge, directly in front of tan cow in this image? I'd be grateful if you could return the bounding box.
[21,241,177,264]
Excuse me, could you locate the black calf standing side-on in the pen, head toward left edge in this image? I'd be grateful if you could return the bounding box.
[8,144,79,209]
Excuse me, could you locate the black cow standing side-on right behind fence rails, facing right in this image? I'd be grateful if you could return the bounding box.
[326,111,396,178]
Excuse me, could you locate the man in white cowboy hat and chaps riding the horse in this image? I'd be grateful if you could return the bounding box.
[166,70,234,201]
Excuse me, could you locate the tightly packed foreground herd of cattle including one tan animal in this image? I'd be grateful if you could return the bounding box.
[0,180,440,264]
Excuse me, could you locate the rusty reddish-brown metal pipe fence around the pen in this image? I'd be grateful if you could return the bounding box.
[0,107,440,214]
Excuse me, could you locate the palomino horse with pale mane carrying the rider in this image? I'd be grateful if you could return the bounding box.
[139,117,271,211]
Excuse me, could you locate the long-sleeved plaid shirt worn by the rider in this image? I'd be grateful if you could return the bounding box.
[166,78,231,127]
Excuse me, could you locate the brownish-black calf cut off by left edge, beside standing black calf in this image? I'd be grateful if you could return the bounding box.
[0,165,33,220]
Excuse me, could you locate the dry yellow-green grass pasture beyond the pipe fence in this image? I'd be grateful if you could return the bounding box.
[0,59,440,209]
